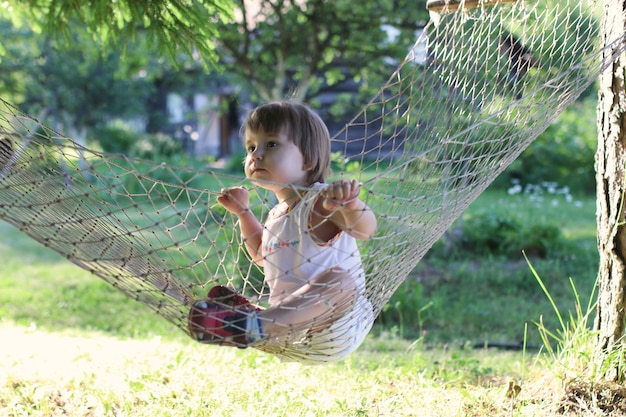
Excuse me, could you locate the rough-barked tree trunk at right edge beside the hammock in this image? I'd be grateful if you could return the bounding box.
[595,0,626,381]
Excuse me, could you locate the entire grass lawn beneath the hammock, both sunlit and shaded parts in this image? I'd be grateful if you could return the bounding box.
[0,186,605,417]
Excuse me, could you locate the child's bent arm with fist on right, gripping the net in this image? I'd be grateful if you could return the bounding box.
[320,180,378,240]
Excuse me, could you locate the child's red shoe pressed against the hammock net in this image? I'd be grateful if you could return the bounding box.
[188,297,249,347]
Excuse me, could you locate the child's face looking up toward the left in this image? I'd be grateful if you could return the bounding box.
[244,130,310,190]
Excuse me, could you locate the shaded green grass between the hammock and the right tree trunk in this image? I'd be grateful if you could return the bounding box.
[372,186,598,348]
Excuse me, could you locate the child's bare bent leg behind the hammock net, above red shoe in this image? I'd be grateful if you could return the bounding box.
[259,268,357,337]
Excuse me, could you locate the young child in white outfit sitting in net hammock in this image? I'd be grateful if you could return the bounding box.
[189,101,377,359]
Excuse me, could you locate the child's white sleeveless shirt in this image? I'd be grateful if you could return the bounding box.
[261,183,365,305]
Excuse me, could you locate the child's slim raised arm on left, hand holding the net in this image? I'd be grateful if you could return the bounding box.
[217,187,263,265]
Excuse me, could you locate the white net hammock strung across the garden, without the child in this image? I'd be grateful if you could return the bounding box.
[0,0,624,361]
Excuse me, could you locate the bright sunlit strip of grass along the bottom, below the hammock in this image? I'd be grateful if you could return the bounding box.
[0,323,564,417]
